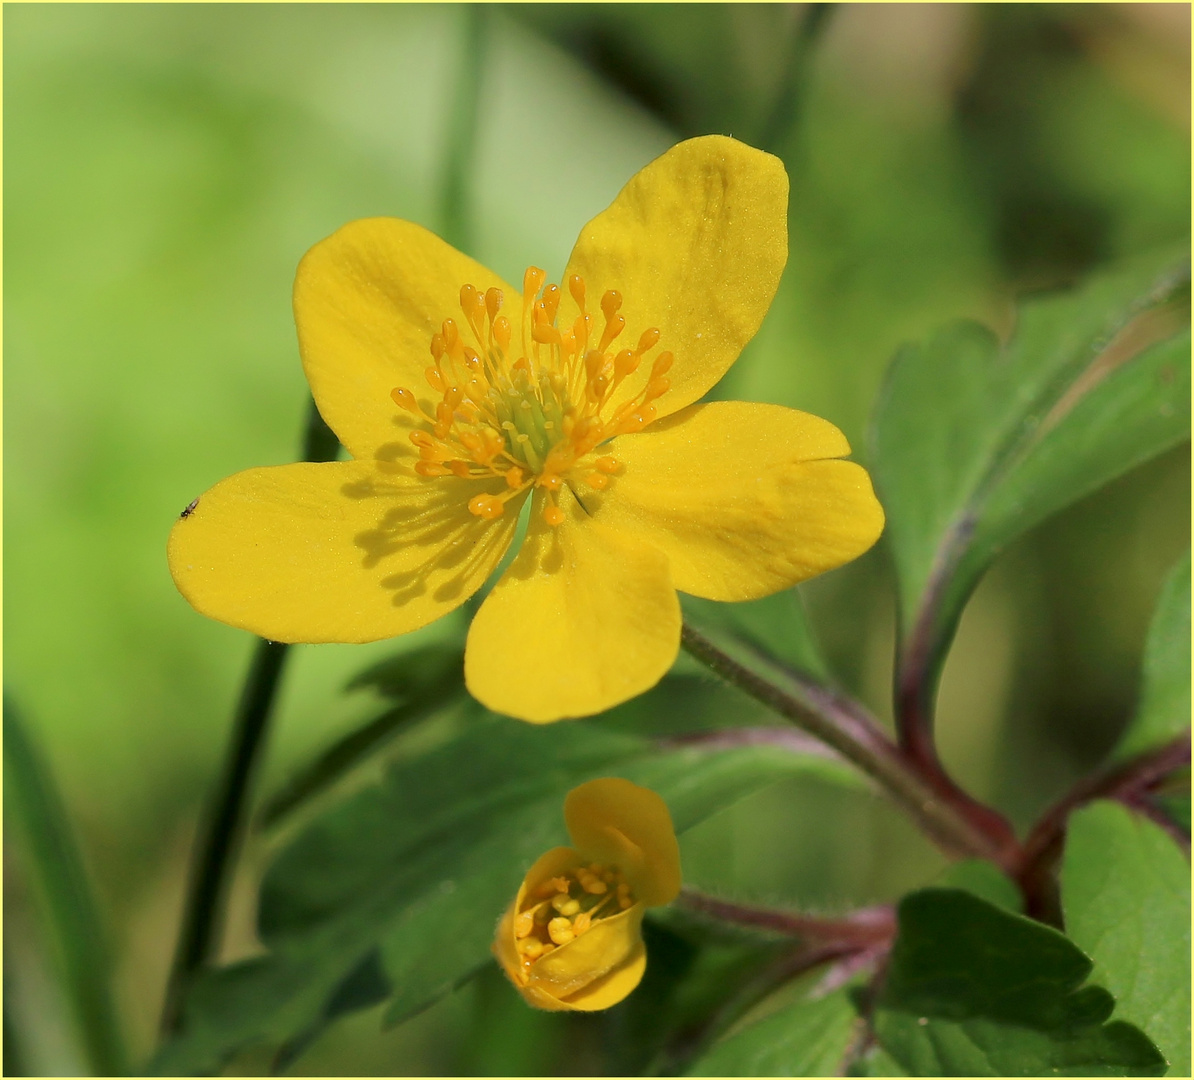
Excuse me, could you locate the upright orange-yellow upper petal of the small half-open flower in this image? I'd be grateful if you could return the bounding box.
[564,777,681,907]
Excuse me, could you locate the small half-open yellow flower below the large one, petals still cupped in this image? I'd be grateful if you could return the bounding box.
[493,779,681,1012]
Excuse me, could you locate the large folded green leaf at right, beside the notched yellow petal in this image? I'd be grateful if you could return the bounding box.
[872,257,1190,675]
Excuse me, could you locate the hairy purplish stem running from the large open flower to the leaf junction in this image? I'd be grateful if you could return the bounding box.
[681,623,1016,866]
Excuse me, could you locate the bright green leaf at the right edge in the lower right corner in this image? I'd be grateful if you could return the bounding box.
[1061,797,1190,1076]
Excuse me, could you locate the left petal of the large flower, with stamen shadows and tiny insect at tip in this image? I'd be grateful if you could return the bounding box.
[168,462,518,642]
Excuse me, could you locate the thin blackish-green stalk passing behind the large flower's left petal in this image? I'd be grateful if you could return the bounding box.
[161,402,339,1033]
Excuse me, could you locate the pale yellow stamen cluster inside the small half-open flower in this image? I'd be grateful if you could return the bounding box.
[515,863,634,968]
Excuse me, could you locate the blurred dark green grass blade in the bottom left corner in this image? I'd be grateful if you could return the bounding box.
[4,697,129,1076]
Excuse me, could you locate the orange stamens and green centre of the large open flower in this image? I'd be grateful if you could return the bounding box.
[390,266,672,525]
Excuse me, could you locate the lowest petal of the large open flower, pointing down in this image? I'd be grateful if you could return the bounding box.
[464,489,681,723]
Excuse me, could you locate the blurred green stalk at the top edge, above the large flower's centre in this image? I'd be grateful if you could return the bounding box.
[439,4,488,251]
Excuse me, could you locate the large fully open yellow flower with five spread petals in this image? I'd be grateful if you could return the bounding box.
[170,136,884,722]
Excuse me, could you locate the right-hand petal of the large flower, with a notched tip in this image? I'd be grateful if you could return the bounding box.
[584,401,884,600]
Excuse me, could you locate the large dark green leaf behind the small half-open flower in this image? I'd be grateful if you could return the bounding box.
[154,717,843,1073]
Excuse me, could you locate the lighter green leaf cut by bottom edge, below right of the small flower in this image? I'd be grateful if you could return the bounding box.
[688,987,858,1076]
